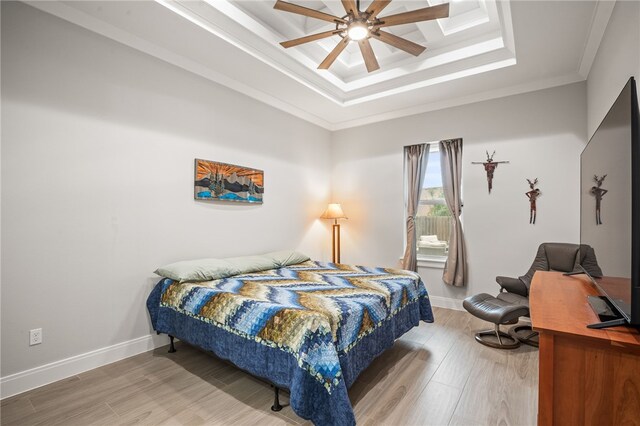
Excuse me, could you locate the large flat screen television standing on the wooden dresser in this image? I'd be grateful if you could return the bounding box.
[580,77,640,328]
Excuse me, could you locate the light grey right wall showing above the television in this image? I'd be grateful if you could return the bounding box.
[587,1,640,137]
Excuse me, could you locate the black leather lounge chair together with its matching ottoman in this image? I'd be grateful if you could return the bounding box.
[463,243,602,349]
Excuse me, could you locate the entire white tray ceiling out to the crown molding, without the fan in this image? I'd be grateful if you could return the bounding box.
[26,0,614,130]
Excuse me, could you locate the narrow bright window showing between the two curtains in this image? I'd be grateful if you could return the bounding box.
[415,143,451,257]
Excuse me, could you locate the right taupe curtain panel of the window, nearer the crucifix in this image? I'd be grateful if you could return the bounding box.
[440,139,467,287]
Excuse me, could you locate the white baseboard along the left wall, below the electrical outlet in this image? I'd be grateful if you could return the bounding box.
[0,334,169,399]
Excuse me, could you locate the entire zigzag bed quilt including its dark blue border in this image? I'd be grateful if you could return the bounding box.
[147,258,433,425]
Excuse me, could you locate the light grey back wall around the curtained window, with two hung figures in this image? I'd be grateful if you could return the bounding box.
[332,83,587,299]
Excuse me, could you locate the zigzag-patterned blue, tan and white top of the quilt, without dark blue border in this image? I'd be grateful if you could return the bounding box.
[148,261,433,421]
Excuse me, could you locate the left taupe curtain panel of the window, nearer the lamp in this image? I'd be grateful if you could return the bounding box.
[402,143,429,271]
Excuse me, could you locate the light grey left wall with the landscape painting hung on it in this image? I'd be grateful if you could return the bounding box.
[1,2,330,376]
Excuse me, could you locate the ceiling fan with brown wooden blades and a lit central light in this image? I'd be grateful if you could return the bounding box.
[273,0,449,72]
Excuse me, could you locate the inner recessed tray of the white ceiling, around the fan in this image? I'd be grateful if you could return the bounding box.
[162,0,516,106]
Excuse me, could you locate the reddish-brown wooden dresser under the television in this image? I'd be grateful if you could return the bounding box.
[529,272,640,426]
